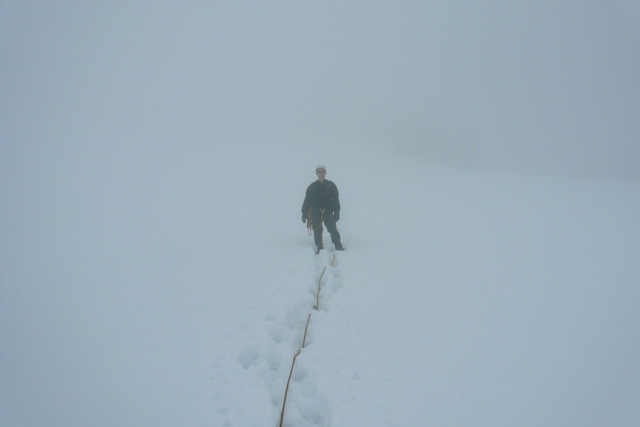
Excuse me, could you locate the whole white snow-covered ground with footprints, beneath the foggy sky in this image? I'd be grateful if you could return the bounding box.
[2,141,640,427]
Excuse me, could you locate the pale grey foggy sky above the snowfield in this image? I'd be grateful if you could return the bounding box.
[0,0,640,181]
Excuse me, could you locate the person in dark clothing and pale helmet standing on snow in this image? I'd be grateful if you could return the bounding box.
[302,165,345,254]
